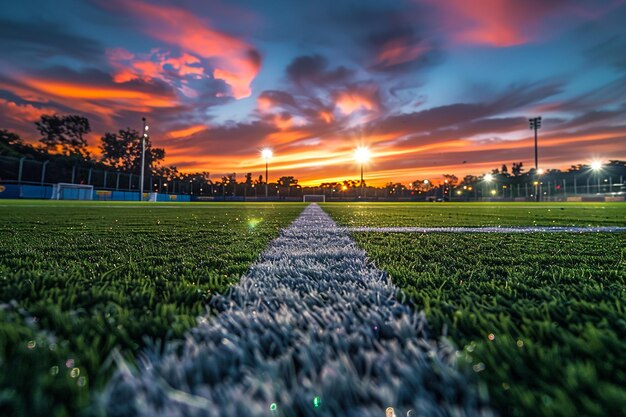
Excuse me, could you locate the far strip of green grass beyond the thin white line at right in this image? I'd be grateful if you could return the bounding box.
[322,202,626,227]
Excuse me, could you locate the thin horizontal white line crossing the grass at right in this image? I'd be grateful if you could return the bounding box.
[346,226,626,233]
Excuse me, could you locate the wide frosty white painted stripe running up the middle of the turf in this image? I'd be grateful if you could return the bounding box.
[101,204,493,417]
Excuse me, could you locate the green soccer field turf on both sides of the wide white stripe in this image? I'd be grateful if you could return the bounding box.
[0,201,626,417]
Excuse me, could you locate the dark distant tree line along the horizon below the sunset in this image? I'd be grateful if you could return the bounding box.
[0,114,626,200]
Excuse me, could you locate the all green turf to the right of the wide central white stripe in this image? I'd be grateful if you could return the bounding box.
[324,204,626,417]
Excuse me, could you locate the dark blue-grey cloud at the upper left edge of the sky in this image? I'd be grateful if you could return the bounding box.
[0,19,104,62]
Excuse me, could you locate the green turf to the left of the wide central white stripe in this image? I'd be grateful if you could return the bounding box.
[0,201,304,417]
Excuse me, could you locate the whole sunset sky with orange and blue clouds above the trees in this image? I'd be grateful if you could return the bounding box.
[0,0,626,184]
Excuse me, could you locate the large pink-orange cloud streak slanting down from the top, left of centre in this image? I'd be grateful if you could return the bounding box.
[123,2,260,99]
